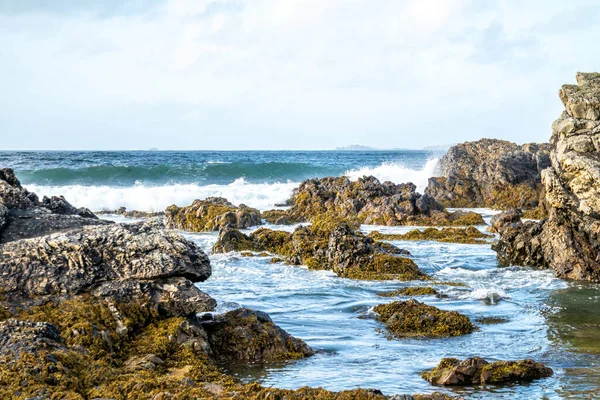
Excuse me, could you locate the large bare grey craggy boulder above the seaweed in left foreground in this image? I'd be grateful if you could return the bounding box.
[0,220,215,315]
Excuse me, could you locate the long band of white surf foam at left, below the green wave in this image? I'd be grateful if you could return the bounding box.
[27,178,298,211]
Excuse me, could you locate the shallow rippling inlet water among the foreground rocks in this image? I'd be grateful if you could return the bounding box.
[134,216,600,399]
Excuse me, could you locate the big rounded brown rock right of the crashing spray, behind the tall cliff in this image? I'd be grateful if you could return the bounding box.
[425,139,551,209]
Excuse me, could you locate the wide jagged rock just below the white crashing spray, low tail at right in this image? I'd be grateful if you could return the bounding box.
[288,176,484,226]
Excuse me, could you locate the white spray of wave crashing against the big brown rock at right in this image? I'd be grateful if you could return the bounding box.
[344,158,438,193]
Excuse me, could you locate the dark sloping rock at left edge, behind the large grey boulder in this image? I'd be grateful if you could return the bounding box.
[0,168,110,243]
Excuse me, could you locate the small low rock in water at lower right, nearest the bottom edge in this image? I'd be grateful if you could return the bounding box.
[421,357,553,386]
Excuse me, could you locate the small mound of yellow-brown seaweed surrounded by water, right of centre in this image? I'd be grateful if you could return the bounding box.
[374,299,475,338]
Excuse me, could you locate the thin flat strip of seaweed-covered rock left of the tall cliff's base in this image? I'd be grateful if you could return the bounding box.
[369,226,493,244]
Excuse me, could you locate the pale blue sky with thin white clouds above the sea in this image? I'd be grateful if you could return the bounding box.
[0,0,600,150]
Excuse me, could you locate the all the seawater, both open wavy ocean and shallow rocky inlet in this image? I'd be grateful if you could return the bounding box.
[0,151,600,399]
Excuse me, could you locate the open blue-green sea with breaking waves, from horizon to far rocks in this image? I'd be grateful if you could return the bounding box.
[0,151,440,211]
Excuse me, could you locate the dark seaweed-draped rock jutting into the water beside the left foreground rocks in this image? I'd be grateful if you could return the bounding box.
[202,308,313,362]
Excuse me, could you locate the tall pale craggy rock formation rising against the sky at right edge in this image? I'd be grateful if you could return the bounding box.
[494,73,600,282]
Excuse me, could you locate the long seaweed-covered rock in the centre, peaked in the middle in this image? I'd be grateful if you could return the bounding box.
[213,217,429,280]
